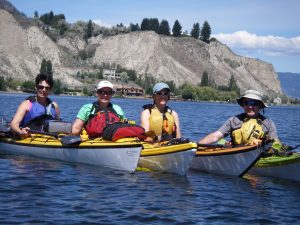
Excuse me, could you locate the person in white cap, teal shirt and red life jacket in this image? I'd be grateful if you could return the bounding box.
[72,80,125,138]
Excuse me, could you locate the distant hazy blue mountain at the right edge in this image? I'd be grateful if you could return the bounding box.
[278,72,300,99]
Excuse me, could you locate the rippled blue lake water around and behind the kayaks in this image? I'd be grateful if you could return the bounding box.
[0,93,300,224]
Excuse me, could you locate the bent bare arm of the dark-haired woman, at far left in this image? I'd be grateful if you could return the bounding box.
[10,100,30,137]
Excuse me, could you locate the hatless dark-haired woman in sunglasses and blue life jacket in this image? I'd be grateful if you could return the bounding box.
[10,73,60,138]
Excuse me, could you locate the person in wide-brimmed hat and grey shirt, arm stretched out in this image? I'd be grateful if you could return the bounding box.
[198,90,278,145]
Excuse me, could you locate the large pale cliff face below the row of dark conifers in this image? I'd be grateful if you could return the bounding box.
[91,31,282,95]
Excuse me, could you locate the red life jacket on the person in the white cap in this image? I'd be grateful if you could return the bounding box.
[85,102,121,138]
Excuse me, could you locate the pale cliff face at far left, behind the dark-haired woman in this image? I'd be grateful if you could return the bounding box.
[0,10,81,86]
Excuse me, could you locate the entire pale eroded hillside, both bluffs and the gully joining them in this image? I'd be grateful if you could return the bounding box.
[0,6,282,95]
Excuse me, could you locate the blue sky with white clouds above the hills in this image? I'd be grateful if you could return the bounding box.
[9,0,300,73]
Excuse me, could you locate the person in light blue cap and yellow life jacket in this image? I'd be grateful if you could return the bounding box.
[141,83,181,142]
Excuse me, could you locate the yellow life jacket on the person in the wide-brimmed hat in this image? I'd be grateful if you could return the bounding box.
[231,113,266,145]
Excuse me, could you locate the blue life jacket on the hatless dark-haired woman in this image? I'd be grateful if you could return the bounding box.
[21,96,56,130]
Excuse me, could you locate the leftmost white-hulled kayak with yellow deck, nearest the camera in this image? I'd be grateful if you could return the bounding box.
[0,134,142,172]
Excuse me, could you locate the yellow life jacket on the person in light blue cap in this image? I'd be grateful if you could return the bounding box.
[143,104,176,138]
